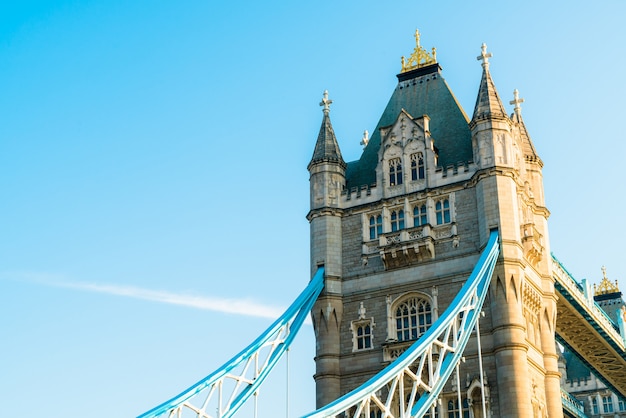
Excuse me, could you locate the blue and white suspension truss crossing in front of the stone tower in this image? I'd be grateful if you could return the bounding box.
[304,231,500,418]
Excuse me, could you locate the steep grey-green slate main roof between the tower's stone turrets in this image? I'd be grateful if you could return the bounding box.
[346,64,473,188]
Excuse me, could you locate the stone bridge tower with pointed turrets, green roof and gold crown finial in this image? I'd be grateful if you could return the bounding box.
[307,32,563,417]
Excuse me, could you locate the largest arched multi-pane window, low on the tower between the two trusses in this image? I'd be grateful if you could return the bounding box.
[394,296,432,341]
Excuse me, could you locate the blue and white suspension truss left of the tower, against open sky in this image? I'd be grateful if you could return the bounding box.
[138,267,324,418]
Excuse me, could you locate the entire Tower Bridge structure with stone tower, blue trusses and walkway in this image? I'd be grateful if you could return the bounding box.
[141,32,626,418]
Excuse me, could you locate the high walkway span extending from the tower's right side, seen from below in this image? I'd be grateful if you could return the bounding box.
[552,256,626,399]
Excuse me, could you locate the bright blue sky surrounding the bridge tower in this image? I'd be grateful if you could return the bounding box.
[0,0,626,418]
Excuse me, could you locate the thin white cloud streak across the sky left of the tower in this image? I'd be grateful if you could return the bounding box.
[1,273,284,319]
